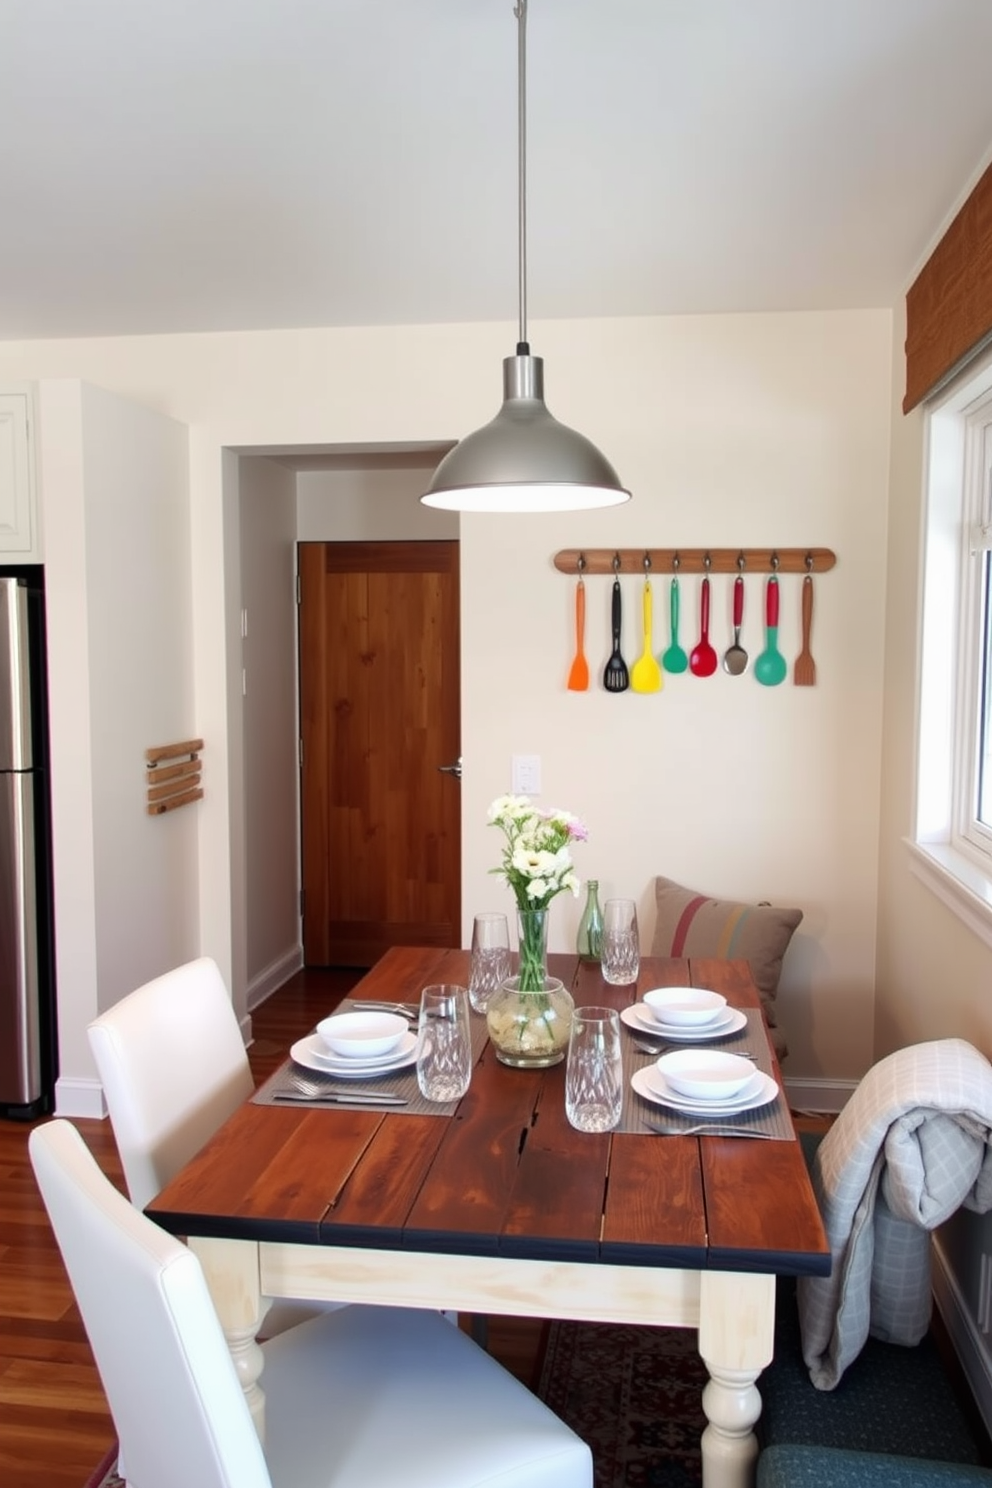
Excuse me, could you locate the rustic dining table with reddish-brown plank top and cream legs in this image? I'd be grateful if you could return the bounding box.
[147,948,830,1488]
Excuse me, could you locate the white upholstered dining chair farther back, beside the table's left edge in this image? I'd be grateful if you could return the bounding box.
[86,955,336,1336]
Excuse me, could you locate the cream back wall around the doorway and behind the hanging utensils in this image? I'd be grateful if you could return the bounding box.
[0,312,891,1077]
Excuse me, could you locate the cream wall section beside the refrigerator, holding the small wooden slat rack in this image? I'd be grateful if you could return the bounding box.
[39,382,197,1109]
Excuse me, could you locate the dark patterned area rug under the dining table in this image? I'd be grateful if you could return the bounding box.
[537,1323,706,1488]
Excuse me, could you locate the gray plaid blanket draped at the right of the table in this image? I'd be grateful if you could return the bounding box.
[797,1039,992,1390]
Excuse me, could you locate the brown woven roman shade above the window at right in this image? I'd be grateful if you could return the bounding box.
[903,165,992,414]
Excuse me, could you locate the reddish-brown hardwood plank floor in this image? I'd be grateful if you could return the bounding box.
[0,970,826,1488]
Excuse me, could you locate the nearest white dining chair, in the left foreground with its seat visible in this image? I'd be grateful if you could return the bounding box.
[28,1120,592,1488]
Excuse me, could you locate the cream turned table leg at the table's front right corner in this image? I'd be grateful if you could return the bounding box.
[699,1271,775,1488]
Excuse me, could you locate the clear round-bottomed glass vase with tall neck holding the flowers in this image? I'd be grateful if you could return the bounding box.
[486,909,574,1068]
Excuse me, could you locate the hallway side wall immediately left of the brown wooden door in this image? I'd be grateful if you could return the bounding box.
[239,460,302,1007]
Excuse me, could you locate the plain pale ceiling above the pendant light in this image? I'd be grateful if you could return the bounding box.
[0,0,992,339]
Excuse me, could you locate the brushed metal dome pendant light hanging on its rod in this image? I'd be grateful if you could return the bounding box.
[421,0,631,512]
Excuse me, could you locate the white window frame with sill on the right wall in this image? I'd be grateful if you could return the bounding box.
[909,346,992,946]
